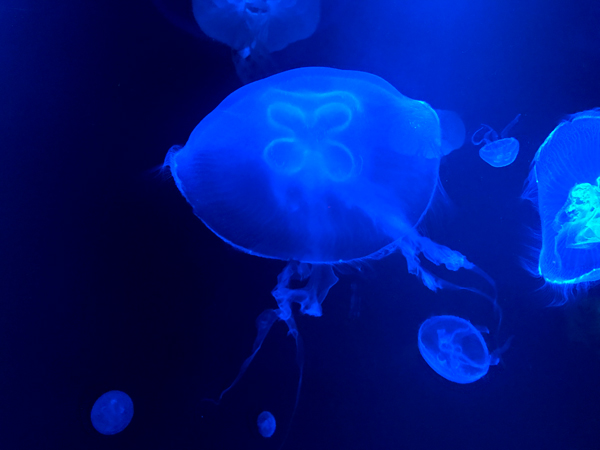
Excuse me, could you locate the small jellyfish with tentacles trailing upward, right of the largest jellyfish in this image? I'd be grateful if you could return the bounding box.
[471,114,521,167]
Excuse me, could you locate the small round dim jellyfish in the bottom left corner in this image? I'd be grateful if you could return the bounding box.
[91,391,133,435]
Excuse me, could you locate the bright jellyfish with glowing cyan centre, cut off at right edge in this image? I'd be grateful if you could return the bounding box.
[523,110,600,304]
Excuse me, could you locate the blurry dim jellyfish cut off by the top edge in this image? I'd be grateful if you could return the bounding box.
[192,0,320,82]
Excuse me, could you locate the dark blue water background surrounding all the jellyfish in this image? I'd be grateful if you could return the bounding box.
[0,0,600,450]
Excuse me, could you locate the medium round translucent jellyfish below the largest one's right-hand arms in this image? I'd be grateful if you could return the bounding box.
[419,316,510,384]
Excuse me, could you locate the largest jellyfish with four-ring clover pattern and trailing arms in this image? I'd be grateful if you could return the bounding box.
[165,67,495,420]
